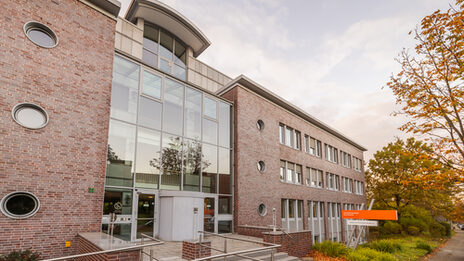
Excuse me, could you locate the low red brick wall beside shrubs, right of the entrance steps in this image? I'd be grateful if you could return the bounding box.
[263,231,312,257]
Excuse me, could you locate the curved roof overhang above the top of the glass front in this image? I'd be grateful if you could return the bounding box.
[126,0,211,57]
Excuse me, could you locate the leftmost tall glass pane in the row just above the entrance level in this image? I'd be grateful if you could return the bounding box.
[106,120,135,187]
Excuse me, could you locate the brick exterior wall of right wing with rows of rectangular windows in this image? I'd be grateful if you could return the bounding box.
[222,87,366,241]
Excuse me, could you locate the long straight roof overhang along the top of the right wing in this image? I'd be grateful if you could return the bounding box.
[216,75,367,151]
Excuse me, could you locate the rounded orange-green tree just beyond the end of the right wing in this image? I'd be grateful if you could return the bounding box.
[366,138,458,218]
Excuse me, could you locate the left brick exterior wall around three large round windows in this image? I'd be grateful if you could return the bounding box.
[0,0,115,258]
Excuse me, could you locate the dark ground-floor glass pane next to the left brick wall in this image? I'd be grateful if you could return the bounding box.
[103,188,132,215]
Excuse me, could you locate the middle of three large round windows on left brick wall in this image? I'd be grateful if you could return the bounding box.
[11,103,48,129]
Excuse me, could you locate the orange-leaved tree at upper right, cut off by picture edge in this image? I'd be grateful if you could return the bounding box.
[387,0,464,169]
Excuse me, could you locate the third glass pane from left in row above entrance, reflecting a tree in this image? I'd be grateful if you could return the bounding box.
[160,133,182,190]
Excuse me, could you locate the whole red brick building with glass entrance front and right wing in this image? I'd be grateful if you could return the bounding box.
[0,0,365,257]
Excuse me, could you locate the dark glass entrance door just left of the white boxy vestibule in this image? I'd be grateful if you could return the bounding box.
[135,193,156,239]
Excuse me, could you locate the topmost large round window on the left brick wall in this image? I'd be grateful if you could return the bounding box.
[24,21,58,48]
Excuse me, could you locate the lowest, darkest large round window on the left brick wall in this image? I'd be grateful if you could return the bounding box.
[0,192,40,219]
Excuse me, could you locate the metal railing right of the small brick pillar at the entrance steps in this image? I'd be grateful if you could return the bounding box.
[193,231,281,261]
